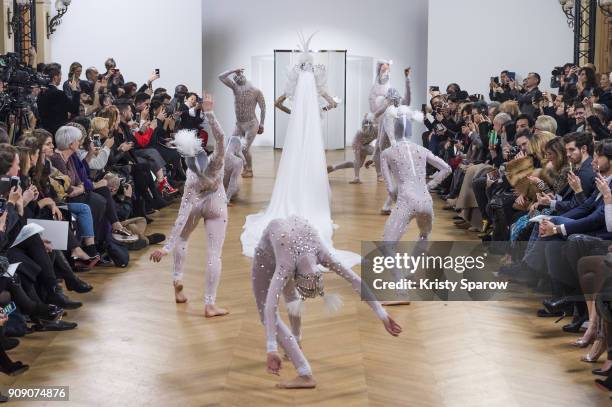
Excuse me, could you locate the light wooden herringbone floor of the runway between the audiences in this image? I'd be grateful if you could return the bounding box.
[0,150,610,407]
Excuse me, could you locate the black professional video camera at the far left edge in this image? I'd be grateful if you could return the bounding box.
[0,52,51,113]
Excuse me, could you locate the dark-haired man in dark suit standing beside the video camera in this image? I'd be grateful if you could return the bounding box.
[37,64,81,135]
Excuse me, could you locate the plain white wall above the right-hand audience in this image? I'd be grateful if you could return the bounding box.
[427,0,573,98]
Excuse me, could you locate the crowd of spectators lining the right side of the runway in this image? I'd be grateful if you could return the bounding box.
[423,64,612,391]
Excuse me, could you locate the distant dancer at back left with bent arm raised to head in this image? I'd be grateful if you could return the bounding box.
[219,69,266,178]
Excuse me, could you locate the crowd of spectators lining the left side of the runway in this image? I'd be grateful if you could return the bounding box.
[0,51,207,396]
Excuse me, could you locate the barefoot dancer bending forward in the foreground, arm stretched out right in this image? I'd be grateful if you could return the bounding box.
[252,216,402,389]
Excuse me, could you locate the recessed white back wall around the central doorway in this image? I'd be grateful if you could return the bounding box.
[202,0,427,145]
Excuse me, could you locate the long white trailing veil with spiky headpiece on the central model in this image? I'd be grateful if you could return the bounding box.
[240,34,361,267]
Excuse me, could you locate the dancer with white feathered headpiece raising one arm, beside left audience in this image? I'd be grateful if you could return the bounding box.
[151,95,228,317]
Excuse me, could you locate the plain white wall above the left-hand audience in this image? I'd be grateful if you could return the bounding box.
[50,0,202,94]
